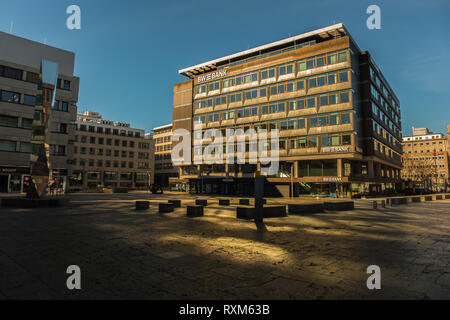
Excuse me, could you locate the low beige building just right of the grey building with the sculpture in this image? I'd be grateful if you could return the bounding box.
[70,111,154,191]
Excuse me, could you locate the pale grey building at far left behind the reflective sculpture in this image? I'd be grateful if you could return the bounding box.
[0,32,79,192]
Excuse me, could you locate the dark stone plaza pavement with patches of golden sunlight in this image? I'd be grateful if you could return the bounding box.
[0,193,450,300]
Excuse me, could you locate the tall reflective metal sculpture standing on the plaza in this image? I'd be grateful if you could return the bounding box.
[27,60,58,199]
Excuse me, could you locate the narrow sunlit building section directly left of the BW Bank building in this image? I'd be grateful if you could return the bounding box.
[152,124,178,190]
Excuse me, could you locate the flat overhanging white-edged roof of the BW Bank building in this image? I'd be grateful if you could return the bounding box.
[178,23,349,78]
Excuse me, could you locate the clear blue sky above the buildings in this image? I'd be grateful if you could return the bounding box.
[0,0,450,135]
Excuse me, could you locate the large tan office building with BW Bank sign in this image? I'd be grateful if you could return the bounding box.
[173,24,402,196]
